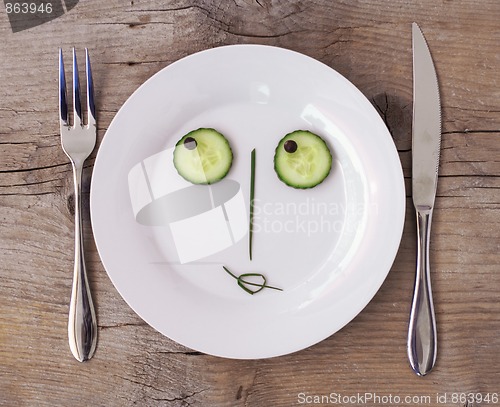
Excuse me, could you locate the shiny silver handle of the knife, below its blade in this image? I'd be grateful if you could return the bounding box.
[407,209,437,376]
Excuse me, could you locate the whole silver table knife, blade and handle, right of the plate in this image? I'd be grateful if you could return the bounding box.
[407,23,441,376]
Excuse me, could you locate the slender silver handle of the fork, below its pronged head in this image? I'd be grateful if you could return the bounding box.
[68,163,97,362]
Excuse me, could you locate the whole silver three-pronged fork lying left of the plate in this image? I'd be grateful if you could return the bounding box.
[59,48,97,362]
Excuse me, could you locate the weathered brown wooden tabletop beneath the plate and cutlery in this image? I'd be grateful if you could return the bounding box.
[0,0,500,407]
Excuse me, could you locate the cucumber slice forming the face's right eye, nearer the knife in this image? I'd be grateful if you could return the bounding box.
[274,130,332,189]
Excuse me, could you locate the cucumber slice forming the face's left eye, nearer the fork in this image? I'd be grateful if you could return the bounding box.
[174,128,233,184]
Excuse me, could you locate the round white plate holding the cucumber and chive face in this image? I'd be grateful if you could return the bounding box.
[91,45,405,359]
